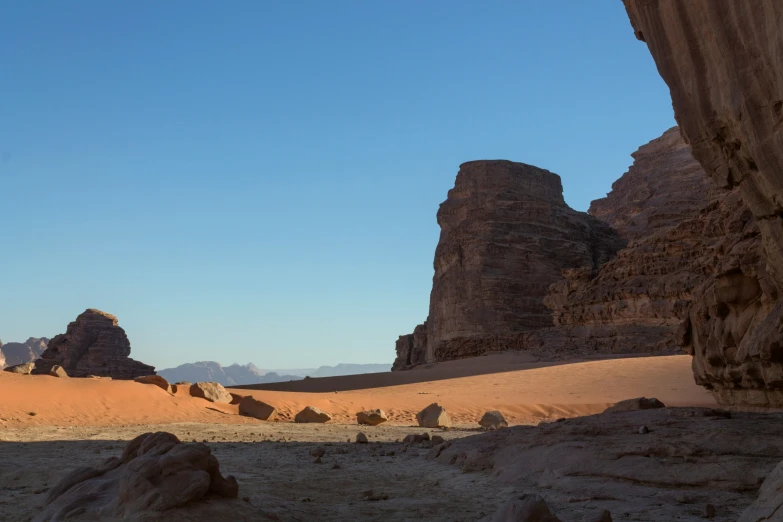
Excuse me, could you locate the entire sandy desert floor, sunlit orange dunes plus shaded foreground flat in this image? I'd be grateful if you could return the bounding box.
[0,355,714,521]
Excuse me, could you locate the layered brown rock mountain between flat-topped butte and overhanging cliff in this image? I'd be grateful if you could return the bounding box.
[540,127,761,355]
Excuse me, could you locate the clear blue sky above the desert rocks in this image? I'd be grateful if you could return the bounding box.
[0,0,674,368]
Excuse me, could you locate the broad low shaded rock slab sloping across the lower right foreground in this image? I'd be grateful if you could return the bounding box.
[429,408,783,522]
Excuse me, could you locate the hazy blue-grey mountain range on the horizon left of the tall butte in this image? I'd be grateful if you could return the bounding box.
[157,361,391,386]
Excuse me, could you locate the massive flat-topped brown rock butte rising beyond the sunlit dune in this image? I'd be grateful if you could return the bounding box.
[394,160,624,369]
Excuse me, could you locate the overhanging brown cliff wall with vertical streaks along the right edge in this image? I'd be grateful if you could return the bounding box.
[624,0,783,407]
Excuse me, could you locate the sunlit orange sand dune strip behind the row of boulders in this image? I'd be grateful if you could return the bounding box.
[0,355,715,427]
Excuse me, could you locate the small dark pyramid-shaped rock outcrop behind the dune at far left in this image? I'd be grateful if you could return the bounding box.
[33,308,155,379]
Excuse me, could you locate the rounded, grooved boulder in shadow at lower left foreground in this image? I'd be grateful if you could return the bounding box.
[34,432,239,522]
